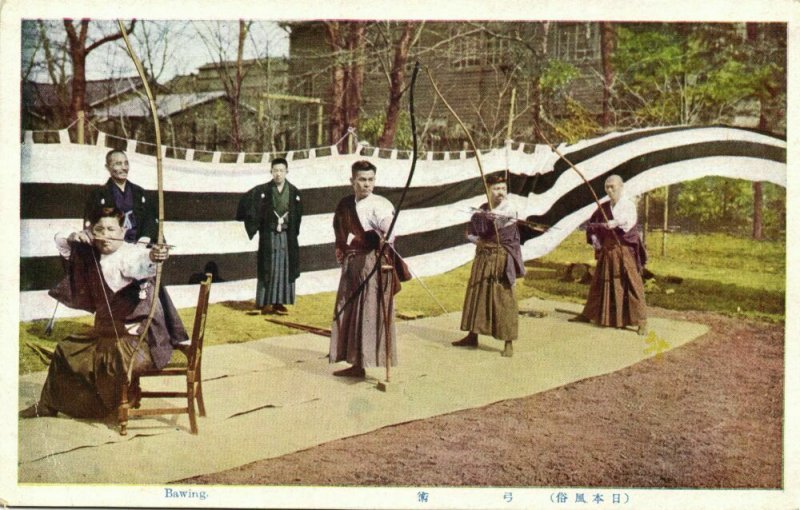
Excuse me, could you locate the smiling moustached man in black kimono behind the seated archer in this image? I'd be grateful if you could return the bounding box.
[83,149,158,243]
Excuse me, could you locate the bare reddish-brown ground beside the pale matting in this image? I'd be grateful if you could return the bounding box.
[182,308,784,488]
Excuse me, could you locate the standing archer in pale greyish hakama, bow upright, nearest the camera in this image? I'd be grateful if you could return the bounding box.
[330,161,408,378]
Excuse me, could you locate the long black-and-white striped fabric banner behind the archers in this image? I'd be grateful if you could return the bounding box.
[20,127,786,320]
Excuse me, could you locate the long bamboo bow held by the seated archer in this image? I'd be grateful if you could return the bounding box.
[117,20,164,381]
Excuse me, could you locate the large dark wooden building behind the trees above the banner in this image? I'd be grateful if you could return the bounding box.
[287,21,603,150]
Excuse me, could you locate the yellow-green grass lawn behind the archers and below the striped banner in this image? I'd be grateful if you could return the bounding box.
[19,232,786,373]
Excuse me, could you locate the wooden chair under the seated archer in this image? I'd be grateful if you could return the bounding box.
[119,273,211,436]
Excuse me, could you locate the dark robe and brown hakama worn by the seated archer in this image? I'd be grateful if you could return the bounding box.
[39,243,188,418]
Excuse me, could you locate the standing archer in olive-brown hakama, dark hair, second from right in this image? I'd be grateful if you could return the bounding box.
[453,174,525,357]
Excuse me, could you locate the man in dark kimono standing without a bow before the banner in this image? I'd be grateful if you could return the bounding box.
[236,158,303,315]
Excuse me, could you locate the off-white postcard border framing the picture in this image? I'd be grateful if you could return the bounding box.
[0,0,800,509]
